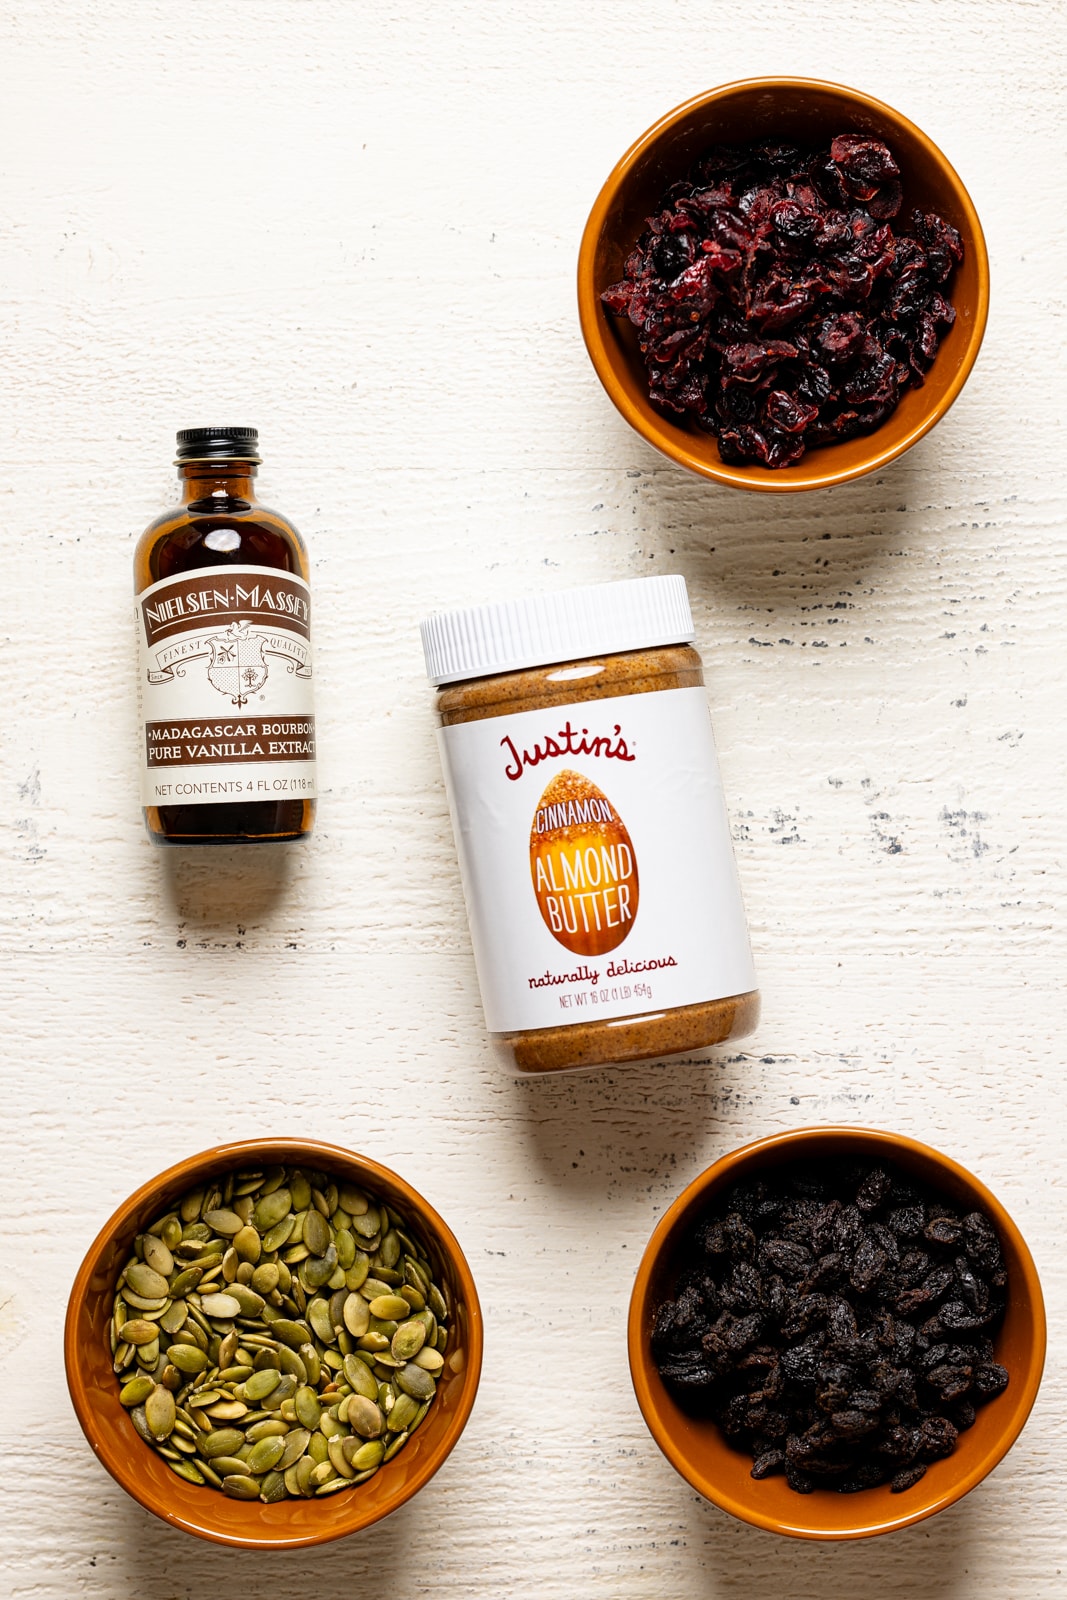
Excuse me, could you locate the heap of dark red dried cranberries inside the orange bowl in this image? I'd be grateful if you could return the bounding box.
[601,133,963,464]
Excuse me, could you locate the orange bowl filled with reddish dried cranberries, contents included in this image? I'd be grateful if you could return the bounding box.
[577,78,989,491]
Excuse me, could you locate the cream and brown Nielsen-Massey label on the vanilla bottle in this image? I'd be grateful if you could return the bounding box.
[136,566,315,806]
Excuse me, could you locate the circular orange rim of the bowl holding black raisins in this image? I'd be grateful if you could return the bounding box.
[627,1123,1048,1541]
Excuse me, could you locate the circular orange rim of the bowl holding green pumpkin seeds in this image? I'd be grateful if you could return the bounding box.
[62,1136,485,1550]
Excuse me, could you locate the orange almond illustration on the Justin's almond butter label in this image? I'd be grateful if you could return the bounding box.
[530,770,638,955]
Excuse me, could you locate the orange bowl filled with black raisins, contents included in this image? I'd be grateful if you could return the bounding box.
[629,1128,1045,1539]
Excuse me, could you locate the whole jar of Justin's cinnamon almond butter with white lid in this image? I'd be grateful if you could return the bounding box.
[422,576,760,1072]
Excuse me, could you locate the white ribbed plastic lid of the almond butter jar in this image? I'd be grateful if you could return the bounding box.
[421,573,694,685]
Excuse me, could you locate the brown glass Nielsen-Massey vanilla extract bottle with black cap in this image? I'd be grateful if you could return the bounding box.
[134,427,315,845]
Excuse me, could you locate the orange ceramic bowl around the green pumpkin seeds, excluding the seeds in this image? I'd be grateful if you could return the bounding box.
[64,1139,482,1550]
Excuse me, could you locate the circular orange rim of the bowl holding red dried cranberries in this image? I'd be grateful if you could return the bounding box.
[577,77,989,494]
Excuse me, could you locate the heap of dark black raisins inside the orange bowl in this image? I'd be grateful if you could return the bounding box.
[653,1158,1008,1493]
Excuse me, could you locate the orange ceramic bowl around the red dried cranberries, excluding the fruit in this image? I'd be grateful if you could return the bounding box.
[577,78,989,493]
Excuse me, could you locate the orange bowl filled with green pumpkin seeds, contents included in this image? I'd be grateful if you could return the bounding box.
[64,1139,482,1549]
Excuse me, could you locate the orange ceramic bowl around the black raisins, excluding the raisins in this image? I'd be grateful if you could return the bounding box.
[629,1128,1045,1539]
